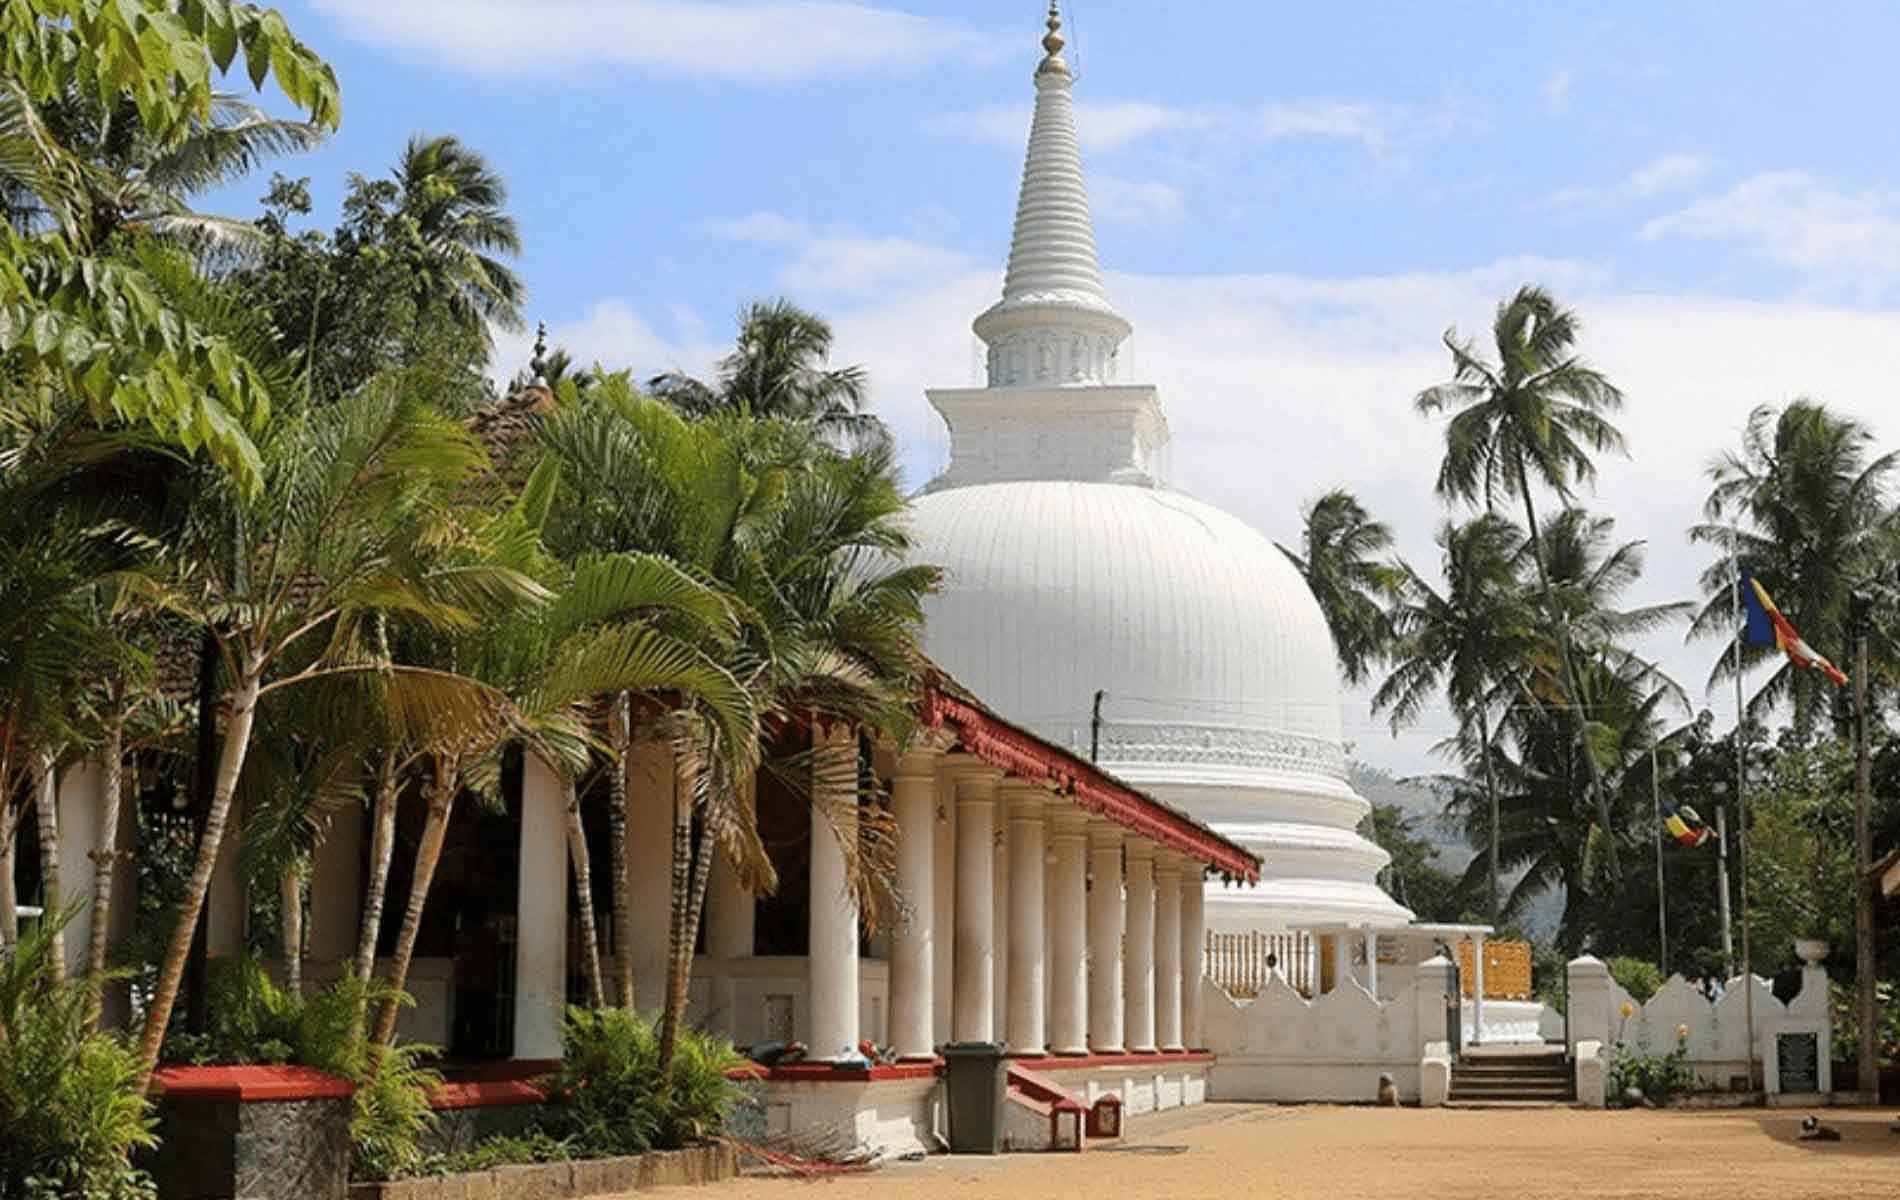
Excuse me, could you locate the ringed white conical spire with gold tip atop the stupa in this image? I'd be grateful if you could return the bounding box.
[975,0,1129,387]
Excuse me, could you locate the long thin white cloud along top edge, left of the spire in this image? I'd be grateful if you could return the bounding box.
[314,0,998,82]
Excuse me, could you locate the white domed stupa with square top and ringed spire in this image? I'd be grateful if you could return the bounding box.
[914,6,1412,932]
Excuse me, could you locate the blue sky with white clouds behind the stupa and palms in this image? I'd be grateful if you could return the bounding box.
[229,0,1900,771]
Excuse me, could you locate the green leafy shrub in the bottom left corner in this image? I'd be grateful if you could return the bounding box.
[0,913,158,1200]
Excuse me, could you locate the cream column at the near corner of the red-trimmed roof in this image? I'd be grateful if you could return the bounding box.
[891,746,942,1059]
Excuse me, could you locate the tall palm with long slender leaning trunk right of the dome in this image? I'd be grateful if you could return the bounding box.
[1414,287,1623,877]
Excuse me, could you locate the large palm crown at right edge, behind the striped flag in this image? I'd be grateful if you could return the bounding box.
[1689,399,1900,729]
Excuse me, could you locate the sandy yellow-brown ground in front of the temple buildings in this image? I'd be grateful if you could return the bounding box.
[680,1105,1900,1200]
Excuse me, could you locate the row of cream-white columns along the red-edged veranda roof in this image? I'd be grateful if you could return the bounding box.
[866,748,1203,1059]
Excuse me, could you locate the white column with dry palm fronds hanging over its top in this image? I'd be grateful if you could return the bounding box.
[806,725,859,1061]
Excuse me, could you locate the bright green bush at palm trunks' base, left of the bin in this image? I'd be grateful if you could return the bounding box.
[542,1008,745,1156]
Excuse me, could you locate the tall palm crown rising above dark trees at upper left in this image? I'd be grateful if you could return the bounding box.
[381,135,526,328]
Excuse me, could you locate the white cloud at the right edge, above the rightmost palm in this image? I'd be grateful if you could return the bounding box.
[1642,171,1900,296]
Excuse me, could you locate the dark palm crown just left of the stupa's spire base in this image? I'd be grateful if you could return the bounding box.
[648,298,891,446]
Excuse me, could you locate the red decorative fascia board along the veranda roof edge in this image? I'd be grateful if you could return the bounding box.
[920,680,1260,883]
